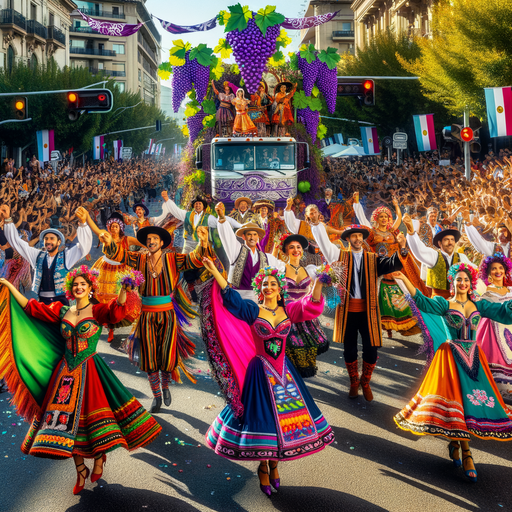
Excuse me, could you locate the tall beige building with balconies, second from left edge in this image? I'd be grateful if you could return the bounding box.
[69,0,161,106]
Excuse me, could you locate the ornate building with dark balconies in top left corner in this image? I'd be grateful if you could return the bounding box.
[0,0,76,69]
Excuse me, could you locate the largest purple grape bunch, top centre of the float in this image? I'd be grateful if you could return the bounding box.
[226,13,281,94]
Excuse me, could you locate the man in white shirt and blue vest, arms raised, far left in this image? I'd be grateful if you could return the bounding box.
[0,204,92,305]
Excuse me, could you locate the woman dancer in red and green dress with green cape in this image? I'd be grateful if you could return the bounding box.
[0,265,161,494]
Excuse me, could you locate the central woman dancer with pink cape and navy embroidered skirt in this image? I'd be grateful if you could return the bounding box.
[203,258,334,496]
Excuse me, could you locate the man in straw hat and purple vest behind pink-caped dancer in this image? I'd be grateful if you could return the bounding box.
[215,203,286,302]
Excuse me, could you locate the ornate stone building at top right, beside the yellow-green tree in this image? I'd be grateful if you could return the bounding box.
[352,0,435,48]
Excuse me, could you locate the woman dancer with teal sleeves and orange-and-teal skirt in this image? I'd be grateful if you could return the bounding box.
[393,263,512,482]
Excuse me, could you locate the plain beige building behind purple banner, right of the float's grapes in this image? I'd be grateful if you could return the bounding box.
[300,0,355,53]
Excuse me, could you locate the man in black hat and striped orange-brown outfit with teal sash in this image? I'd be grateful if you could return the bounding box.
[100,226,213,413]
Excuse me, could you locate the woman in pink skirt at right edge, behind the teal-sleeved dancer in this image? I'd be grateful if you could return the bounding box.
[476,253,512,401]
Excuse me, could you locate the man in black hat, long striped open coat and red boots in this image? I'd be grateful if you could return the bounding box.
[311,224,407,402]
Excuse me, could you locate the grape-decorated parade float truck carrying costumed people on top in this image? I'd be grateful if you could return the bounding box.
[159,4,340,206]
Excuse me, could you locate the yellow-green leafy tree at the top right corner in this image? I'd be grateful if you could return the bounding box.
[399,0,512,117]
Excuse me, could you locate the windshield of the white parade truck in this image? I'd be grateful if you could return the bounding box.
[213,143,295,171]
